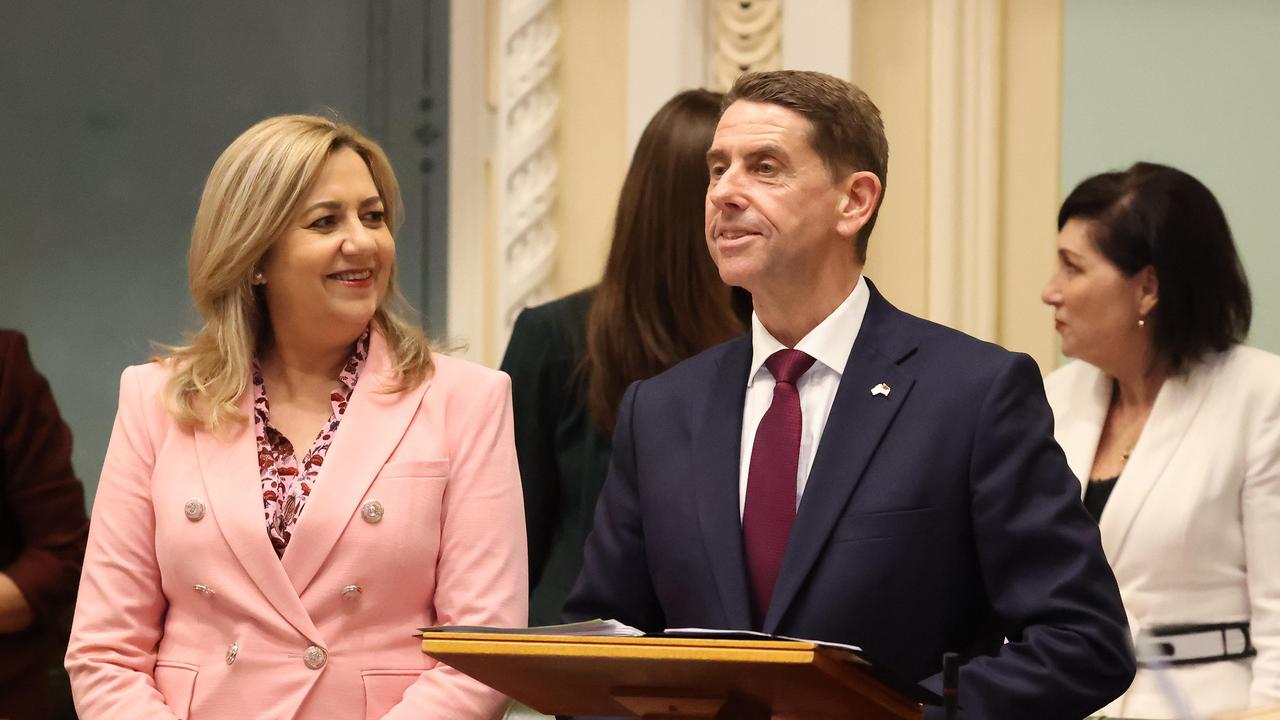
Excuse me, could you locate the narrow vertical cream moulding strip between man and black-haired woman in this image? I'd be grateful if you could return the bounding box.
[928,0,1002,341]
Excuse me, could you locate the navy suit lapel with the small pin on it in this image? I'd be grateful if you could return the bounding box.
[764,281,915,633]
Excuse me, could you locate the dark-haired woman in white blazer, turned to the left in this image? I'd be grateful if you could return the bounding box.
[1042,163,1280,717]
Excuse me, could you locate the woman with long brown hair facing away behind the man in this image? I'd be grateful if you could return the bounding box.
[502,90,750,624]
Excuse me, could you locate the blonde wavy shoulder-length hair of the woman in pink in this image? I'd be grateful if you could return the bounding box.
[157,115,433,432]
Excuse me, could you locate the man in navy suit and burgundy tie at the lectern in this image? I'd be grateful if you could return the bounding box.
[566,72,1134,720]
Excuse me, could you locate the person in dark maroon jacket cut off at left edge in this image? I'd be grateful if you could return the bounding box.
[0,331,88,720]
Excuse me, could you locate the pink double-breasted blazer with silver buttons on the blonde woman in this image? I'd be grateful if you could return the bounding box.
[67,333,529,720]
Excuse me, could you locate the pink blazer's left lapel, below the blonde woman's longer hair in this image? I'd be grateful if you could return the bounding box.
[195,392,323,642]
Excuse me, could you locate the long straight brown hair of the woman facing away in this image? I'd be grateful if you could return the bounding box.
[582,90,744,432]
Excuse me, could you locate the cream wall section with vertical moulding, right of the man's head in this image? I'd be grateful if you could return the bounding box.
[852,0,1061,370]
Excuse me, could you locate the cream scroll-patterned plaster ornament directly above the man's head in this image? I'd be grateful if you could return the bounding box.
[710,0,782,91]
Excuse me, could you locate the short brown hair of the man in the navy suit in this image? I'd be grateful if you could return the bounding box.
[721,70,888,263]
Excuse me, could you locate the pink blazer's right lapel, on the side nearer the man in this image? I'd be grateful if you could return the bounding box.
[280,332,430,596]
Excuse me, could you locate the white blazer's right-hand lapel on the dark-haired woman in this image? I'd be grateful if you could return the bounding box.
[1100,364,1211,564]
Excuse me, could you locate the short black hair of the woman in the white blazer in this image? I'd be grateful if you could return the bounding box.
[1057,163,1253,374]
